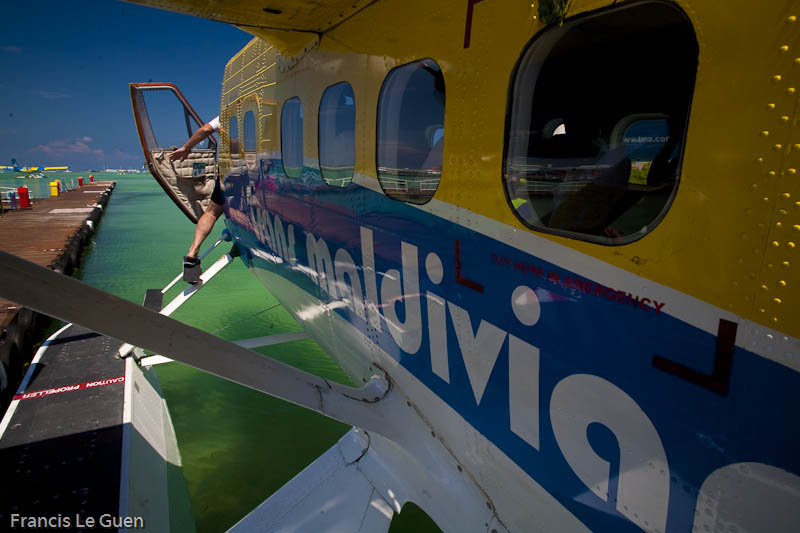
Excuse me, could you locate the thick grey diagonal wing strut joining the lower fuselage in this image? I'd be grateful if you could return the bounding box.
[0,250,396,433]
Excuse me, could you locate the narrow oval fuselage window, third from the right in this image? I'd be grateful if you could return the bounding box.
[319,82,356,187]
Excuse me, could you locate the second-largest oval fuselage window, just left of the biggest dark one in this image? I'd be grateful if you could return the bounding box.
[377,59,445,204]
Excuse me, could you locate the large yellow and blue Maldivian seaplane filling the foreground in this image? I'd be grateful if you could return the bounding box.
[4,0,800,533]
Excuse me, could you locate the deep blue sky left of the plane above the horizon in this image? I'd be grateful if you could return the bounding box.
[0,0,252,171]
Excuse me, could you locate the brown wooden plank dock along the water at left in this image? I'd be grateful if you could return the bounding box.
[0,181,116,327]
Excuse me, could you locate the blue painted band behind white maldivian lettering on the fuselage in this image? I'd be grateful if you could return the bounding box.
[220,162,800,531]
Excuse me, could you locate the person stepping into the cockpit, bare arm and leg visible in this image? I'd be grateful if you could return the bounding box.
[169,116,220,285]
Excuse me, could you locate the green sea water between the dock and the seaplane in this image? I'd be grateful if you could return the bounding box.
[17,172,438,532]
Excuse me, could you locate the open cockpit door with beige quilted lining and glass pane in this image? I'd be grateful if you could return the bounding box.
[130,83,217,224]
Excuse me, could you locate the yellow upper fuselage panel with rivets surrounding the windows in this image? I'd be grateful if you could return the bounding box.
[220,0,800,337]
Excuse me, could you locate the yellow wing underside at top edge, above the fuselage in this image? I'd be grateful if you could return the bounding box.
[127,0,376,56]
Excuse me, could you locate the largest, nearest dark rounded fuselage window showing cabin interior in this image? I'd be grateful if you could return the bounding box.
[503,2,698,244]
